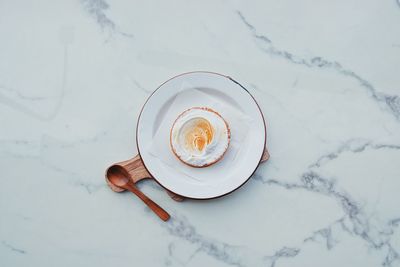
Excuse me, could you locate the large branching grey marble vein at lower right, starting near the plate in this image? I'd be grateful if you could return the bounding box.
[253,139,400,266]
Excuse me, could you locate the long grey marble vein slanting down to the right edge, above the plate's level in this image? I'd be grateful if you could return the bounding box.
[236,11,400,121]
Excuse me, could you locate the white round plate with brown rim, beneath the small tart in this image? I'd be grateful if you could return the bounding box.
[136,72,266,199]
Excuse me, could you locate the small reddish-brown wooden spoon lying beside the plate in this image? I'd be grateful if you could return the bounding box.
[107,165,170,221]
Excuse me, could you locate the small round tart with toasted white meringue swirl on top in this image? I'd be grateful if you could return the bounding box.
[170,107,230,168]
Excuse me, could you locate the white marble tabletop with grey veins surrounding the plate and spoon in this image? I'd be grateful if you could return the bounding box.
[0,0,400,267]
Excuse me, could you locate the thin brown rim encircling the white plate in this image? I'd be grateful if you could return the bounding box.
[136,71,267,200]
